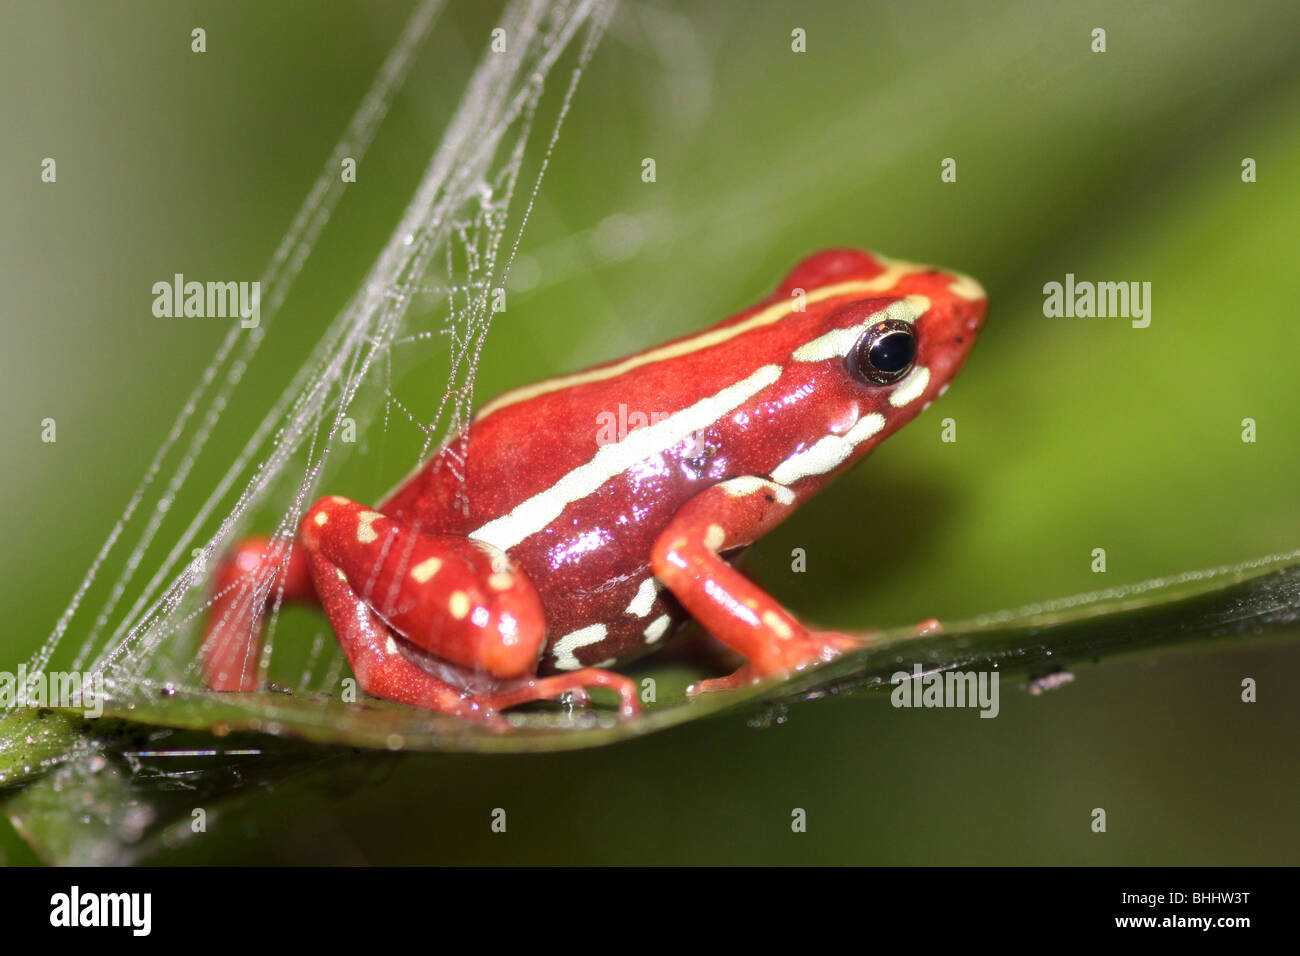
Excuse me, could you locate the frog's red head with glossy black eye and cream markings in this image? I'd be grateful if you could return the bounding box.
[771,250,987,485]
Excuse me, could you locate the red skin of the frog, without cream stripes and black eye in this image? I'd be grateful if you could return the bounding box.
[205,250,987,715]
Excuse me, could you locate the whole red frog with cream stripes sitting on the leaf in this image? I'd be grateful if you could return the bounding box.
[200,250,987,723]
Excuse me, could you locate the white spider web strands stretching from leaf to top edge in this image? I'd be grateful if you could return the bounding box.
[5,0,614,713]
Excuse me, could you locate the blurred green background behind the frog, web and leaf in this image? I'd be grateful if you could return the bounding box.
[0,0,1300,864]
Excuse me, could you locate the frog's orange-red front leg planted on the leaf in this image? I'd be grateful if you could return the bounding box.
[651,477,861,693]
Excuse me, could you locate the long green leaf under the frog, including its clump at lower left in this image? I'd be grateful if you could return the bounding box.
[0,553,1300,865]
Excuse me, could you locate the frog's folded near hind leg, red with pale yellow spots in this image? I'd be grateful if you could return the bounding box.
[299,497,638,719]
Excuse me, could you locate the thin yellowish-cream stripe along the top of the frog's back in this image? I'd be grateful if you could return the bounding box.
[475,256,930,420]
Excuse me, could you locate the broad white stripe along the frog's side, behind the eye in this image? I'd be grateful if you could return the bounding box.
[469,365,781,551]
